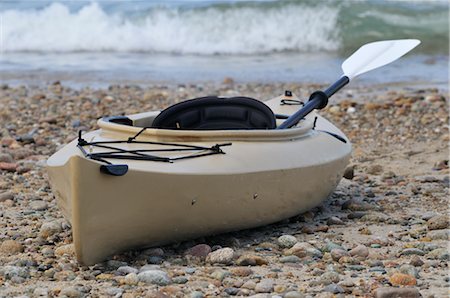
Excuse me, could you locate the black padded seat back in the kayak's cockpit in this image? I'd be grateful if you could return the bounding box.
[152,96,276,130]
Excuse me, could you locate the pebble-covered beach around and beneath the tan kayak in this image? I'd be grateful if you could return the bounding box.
[0,78,450,298]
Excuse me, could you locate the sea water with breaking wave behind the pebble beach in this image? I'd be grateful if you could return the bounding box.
[0,0,449,86]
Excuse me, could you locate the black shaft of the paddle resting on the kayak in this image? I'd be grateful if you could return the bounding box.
[277,76,350,129]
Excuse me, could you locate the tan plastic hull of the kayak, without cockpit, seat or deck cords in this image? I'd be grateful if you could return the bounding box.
[48,94,351,265]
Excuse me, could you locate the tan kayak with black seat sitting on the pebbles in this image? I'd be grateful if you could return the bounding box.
[47,91,351,265]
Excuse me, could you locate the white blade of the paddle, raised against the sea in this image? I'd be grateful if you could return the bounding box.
[342,39,420,80]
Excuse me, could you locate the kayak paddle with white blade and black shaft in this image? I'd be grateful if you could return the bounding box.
[277,39,420,129]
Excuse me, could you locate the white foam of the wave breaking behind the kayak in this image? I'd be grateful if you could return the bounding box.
[0,3,339,55]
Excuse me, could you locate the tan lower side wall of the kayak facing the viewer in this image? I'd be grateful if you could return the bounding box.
[72,151,349,265]
